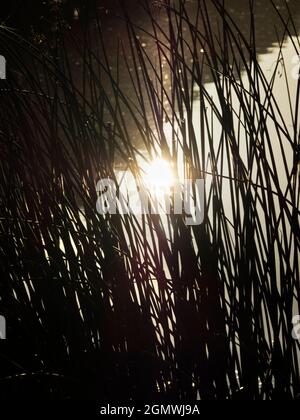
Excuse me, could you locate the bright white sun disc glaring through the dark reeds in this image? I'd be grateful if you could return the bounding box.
[143,158,175,190]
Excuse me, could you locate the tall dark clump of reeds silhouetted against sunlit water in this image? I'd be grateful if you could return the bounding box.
[0,0,300,401]
